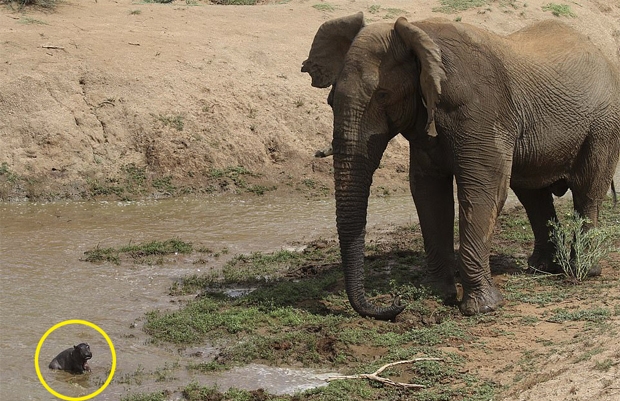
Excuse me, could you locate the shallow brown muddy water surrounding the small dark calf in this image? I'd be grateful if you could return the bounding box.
[0,192,415,400]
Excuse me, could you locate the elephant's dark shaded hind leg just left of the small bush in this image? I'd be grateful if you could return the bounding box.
[513,185,562,274]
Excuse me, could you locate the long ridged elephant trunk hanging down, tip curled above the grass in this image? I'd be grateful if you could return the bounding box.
[334,137,404,320]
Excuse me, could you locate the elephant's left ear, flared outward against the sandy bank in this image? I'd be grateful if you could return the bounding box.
[301,12,365,88]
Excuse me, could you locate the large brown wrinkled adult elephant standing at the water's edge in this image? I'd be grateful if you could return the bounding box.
[302,13,620,320]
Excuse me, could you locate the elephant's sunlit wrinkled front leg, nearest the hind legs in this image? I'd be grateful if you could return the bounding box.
[457,169,509,316]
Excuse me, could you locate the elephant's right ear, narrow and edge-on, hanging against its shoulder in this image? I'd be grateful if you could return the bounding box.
[394,17,446,136]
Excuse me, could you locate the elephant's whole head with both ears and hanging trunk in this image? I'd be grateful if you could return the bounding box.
[301,12,445,320]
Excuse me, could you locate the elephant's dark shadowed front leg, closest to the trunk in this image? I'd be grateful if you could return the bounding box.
[411,171,457,304]
